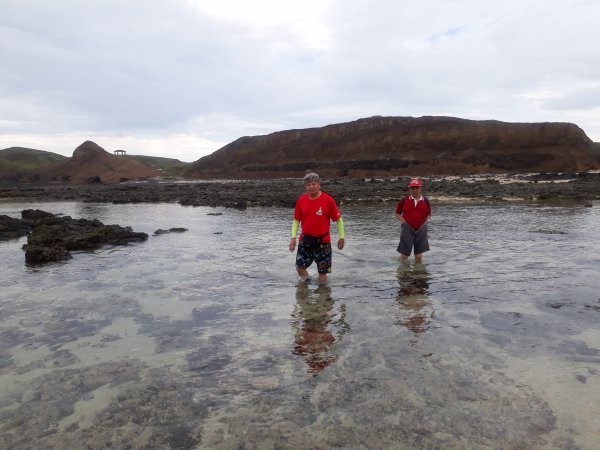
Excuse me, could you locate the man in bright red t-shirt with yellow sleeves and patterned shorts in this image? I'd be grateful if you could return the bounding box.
[290,173,345,282]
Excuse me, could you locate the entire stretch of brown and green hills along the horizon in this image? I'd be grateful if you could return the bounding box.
[0,116,600,185]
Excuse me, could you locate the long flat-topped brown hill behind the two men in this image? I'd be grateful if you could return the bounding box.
[184,116,600,178]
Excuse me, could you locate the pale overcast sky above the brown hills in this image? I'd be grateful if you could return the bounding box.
[0,0,600,162]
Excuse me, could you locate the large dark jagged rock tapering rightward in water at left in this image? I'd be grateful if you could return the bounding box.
[15,210,148,264]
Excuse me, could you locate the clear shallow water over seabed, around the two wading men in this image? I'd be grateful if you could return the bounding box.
[0,203,600,449]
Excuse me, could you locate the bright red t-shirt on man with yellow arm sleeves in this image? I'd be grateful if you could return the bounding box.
[294,192,342,243]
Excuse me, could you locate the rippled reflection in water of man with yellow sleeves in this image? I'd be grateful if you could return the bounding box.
[291,282,350,376]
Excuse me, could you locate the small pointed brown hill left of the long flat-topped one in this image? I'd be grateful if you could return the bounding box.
[30,141,160,184]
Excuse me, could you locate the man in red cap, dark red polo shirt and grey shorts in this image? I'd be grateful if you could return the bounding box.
[396,179,431,262]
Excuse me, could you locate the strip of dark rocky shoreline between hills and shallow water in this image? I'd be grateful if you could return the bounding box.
[0,172,600,209]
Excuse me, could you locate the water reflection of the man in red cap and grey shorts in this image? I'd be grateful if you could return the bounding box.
[396,263,434,333]
